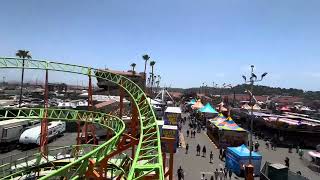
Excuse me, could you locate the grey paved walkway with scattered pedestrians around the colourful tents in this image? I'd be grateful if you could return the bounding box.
[174,113,320,180]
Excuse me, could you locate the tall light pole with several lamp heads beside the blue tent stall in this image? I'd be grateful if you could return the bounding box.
[242,65,268,176]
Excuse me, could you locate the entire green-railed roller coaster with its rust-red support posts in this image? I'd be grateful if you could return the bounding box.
[0,57,174,180]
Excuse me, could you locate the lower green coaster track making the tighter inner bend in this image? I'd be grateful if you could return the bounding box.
[0,108,125,179]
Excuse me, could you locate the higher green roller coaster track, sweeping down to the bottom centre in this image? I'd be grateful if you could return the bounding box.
[0,57,164,180]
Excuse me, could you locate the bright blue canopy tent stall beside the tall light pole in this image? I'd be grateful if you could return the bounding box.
[226,144,262,176]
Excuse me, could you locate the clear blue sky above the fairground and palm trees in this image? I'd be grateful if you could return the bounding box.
[0,0,320,90]
